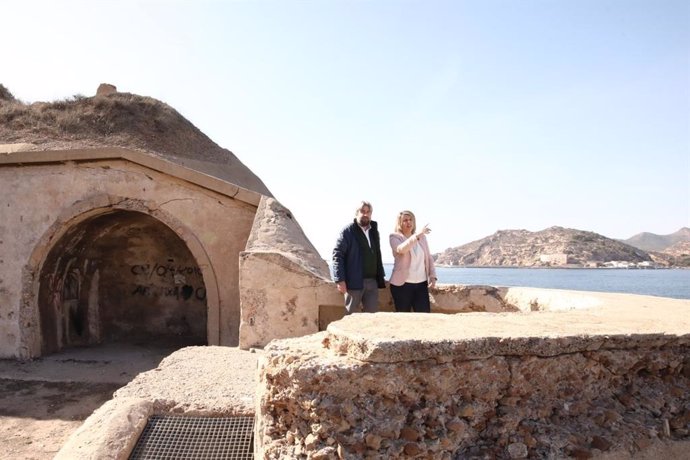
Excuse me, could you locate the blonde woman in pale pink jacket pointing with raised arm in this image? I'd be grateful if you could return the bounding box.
[389,211,436,313]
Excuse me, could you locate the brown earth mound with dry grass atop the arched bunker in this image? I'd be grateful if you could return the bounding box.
[0,85,271,196]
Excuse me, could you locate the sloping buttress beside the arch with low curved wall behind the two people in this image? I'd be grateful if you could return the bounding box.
[239,197,648,349]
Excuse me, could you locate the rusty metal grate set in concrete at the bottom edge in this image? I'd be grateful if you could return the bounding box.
[129,415,254,460]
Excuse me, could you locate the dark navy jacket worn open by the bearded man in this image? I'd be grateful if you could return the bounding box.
[333,220,386,289]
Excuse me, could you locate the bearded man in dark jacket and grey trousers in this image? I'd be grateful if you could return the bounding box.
[333,201,386,315]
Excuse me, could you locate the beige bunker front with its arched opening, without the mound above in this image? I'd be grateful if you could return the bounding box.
[0,148,262,358]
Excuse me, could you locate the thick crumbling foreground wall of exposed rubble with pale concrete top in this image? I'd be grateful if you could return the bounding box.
[255,295,690,459]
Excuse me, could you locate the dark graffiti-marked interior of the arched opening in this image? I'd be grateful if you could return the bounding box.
[39,211,207,354]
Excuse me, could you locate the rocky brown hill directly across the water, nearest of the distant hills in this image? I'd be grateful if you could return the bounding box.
[436,227,652,267]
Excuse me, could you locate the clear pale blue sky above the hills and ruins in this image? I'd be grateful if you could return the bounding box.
[5,0,690,261]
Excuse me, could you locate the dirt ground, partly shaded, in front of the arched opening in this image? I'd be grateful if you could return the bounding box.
[0,345,172,460]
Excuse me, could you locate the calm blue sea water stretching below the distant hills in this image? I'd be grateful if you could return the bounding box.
[384,264,690,299]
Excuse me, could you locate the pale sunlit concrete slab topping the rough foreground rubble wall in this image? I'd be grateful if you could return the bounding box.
[325,293,690,363]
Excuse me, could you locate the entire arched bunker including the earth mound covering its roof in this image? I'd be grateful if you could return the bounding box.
[0,85,328,358]
